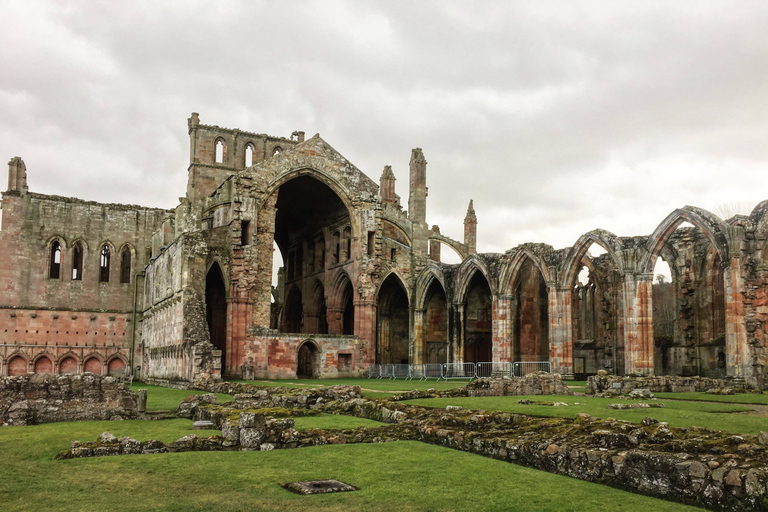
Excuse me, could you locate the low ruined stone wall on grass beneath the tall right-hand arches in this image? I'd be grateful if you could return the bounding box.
[585,375,743,395]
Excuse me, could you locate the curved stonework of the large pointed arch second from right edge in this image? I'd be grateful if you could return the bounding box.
[638,206,730,274]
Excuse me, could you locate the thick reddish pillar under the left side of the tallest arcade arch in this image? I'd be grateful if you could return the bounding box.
[622,273,654,375]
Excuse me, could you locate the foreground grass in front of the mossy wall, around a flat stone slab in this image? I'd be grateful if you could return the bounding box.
[0,420,700,512]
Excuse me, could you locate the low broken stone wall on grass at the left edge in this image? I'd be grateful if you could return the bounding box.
[0,373,138,425]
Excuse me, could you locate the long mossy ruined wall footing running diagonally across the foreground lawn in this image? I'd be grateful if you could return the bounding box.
[57,385,768,511]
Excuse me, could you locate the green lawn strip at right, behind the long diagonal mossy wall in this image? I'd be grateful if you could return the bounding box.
[407,395,768,434]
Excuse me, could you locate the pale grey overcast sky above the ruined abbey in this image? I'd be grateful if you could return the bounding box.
[0,0,768,252]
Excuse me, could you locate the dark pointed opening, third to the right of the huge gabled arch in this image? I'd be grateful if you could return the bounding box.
[464,271,493,363]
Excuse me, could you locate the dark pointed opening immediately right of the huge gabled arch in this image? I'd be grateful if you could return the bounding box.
[376,274,410,364]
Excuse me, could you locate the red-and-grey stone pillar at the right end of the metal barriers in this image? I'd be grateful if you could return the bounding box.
[548,286,573,378]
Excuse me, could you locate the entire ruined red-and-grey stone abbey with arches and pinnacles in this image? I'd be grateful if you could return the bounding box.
[0,113,768,388]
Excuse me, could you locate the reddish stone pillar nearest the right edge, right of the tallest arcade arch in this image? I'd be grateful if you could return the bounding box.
[723,257,752,380]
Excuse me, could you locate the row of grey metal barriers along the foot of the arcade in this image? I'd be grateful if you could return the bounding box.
[368,361,552,380]
